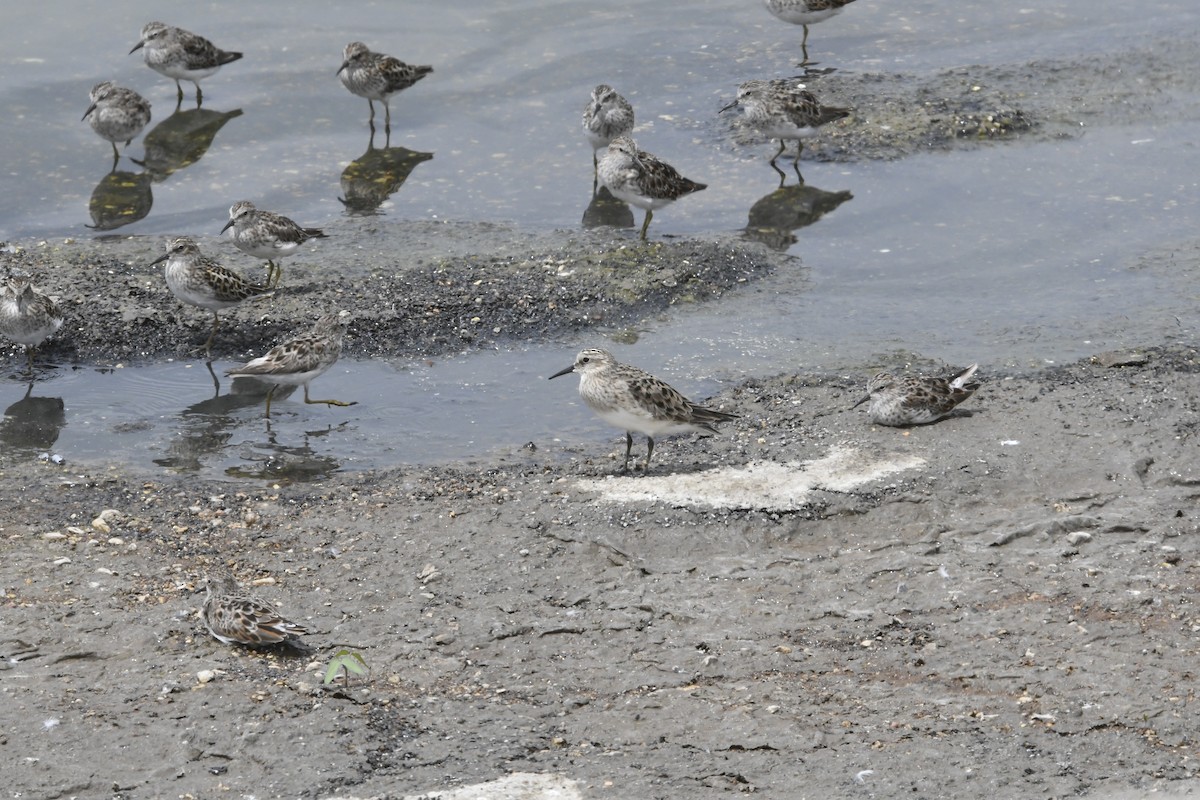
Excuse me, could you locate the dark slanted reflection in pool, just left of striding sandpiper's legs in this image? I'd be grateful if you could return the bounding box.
[154,361,295,473]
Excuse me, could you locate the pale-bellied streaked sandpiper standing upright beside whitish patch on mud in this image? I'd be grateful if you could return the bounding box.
[550,349,737,471]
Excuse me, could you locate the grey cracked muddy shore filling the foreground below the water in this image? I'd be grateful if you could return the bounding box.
[0,335,1200,798]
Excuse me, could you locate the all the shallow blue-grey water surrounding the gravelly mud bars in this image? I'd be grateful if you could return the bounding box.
[0,0,1200,475]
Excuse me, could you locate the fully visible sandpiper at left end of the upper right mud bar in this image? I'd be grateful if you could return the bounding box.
[721,80,850,172]
